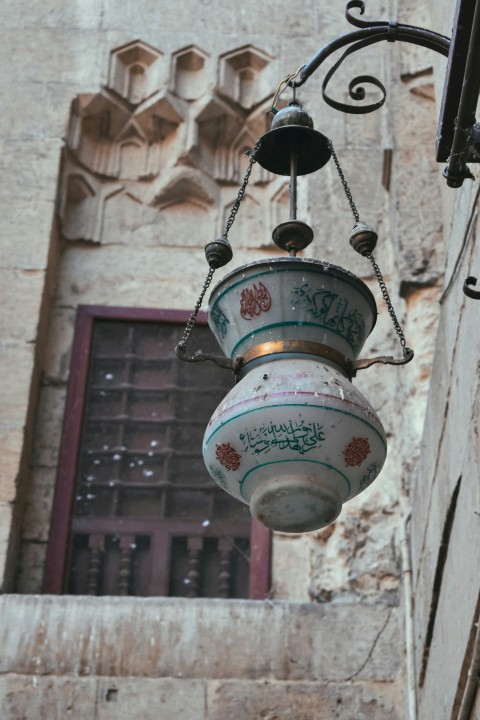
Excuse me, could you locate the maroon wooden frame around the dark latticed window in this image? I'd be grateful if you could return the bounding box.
[43,305,271,600]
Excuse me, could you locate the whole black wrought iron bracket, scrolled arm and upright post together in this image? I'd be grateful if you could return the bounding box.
[287,0,480,188]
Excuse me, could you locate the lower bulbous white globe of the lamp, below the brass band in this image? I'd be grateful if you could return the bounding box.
[203,358,387,533]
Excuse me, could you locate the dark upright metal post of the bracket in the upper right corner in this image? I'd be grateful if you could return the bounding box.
[444,0,480,187]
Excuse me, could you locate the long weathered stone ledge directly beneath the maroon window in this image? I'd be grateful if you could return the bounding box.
[0,595,402,682]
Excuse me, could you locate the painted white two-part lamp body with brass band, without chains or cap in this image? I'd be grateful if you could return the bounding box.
[203,257,386,532]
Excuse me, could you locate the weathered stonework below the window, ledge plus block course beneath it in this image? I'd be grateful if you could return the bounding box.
[0,595,403,720]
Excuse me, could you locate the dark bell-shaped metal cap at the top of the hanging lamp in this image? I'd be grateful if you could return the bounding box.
[255,103,331,175]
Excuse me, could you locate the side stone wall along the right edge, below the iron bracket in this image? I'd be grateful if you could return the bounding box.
[404,2,480,720]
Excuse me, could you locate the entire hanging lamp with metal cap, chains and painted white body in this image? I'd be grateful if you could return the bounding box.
[176,98,413,533]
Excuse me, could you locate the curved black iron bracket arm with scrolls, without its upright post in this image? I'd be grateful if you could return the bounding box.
[288,0,450,115]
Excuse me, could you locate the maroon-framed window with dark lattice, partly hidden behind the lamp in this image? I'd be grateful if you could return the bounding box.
[44,306,270,599]
